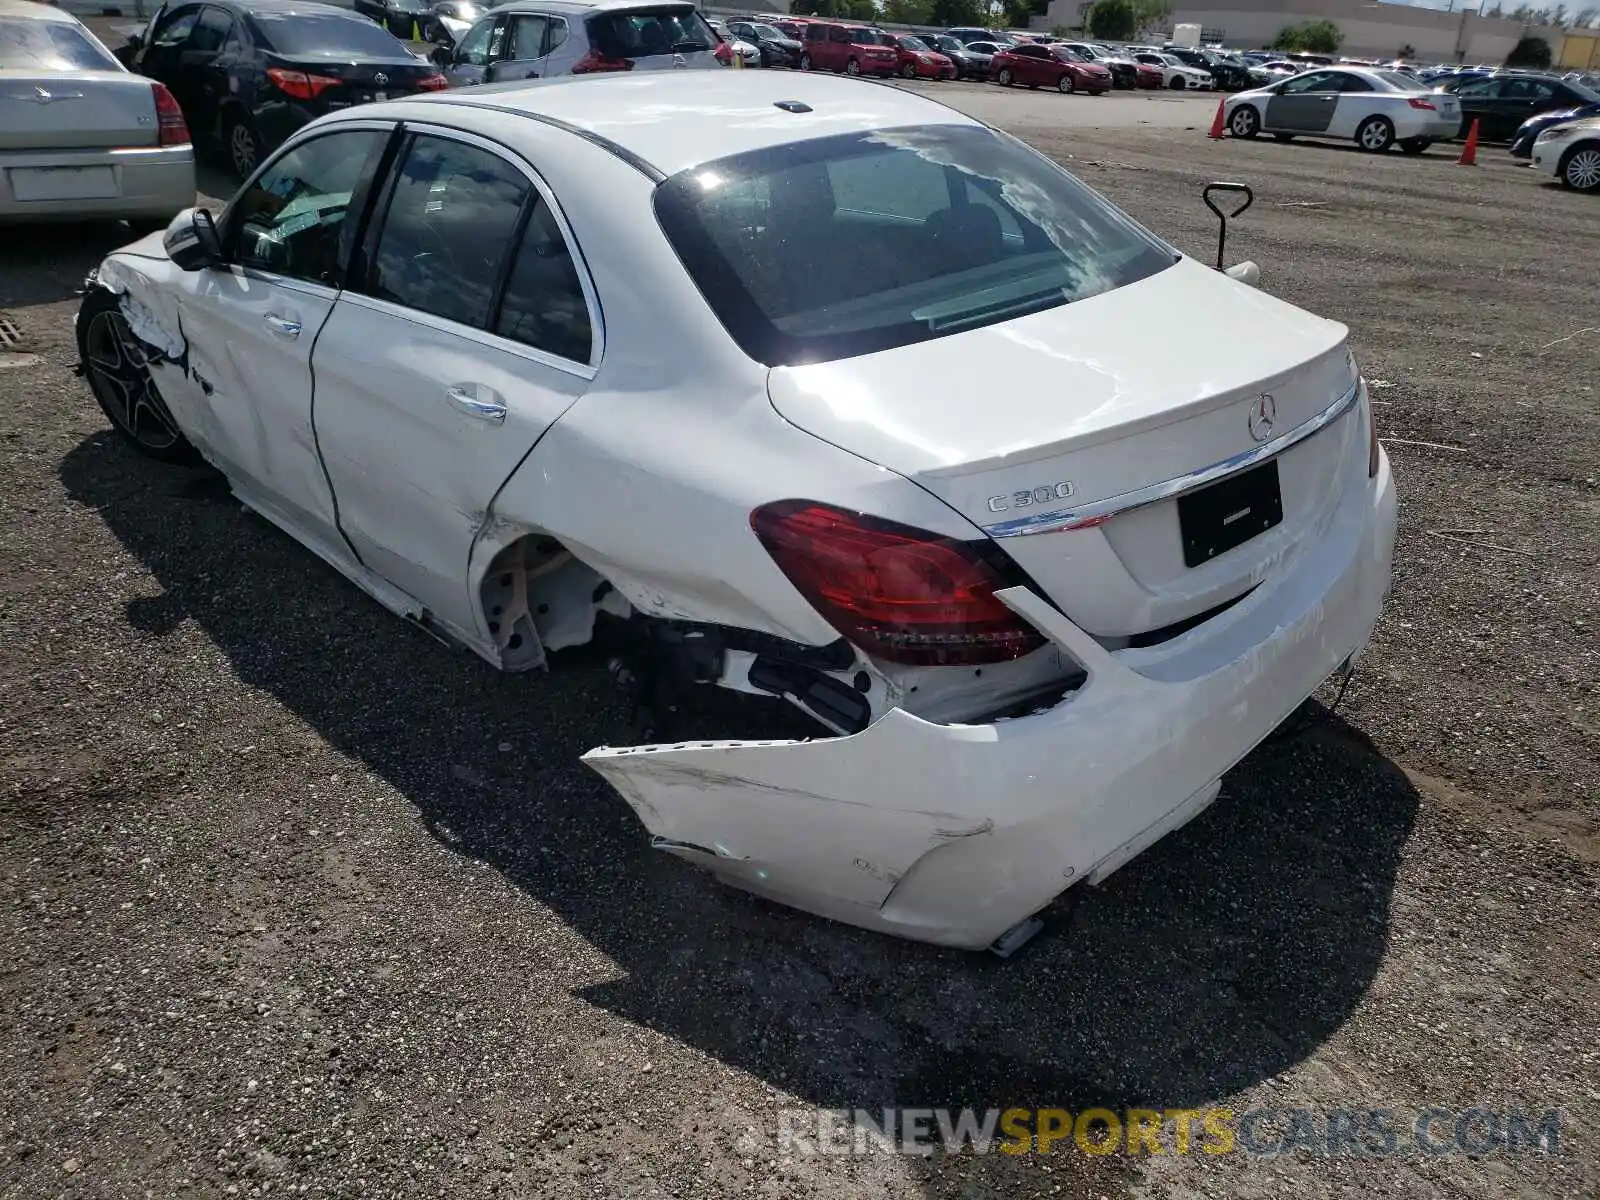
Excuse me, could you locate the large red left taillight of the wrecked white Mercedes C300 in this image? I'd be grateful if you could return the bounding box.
[750,501,1045,666]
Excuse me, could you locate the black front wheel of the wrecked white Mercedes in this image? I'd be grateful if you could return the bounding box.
[77,288,200,462]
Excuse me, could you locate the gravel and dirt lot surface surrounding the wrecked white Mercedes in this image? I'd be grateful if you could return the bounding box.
[0,86,1600,1200]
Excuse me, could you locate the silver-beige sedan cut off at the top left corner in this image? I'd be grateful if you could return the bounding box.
[0,0,195,229]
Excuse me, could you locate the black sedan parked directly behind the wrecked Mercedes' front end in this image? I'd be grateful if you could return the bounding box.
[128,0,446,179]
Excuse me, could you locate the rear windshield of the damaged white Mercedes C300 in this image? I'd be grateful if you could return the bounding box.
[656,125,1178,366]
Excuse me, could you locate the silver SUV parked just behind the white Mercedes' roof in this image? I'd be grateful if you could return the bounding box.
[434,0,733,88]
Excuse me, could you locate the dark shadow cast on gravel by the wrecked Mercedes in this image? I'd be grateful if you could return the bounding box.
[61,434,1418,1197]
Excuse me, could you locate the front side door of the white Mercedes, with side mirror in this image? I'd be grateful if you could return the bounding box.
[176,123,389,542]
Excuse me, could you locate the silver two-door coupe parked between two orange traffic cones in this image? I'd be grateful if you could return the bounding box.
[1222,67,1461,154]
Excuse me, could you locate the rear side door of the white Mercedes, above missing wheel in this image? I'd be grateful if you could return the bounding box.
[314,129,600,632]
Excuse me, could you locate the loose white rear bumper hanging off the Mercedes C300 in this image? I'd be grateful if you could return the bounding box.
[584,454,1395,949]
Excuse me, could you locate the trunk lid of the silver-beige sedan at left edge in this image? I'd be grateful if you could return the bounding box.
[0,70,158,150]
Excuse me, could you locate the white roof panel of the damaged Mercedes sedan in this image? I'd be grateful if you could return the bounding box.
[396,70,981,174]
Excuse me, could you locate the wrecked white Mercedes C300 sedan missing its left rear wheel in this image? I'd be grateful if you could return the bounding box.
[78,70,1395,952]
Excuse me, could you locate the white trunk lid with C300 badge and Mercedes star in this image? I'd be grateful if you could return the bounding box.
[768,259,1366,637]
